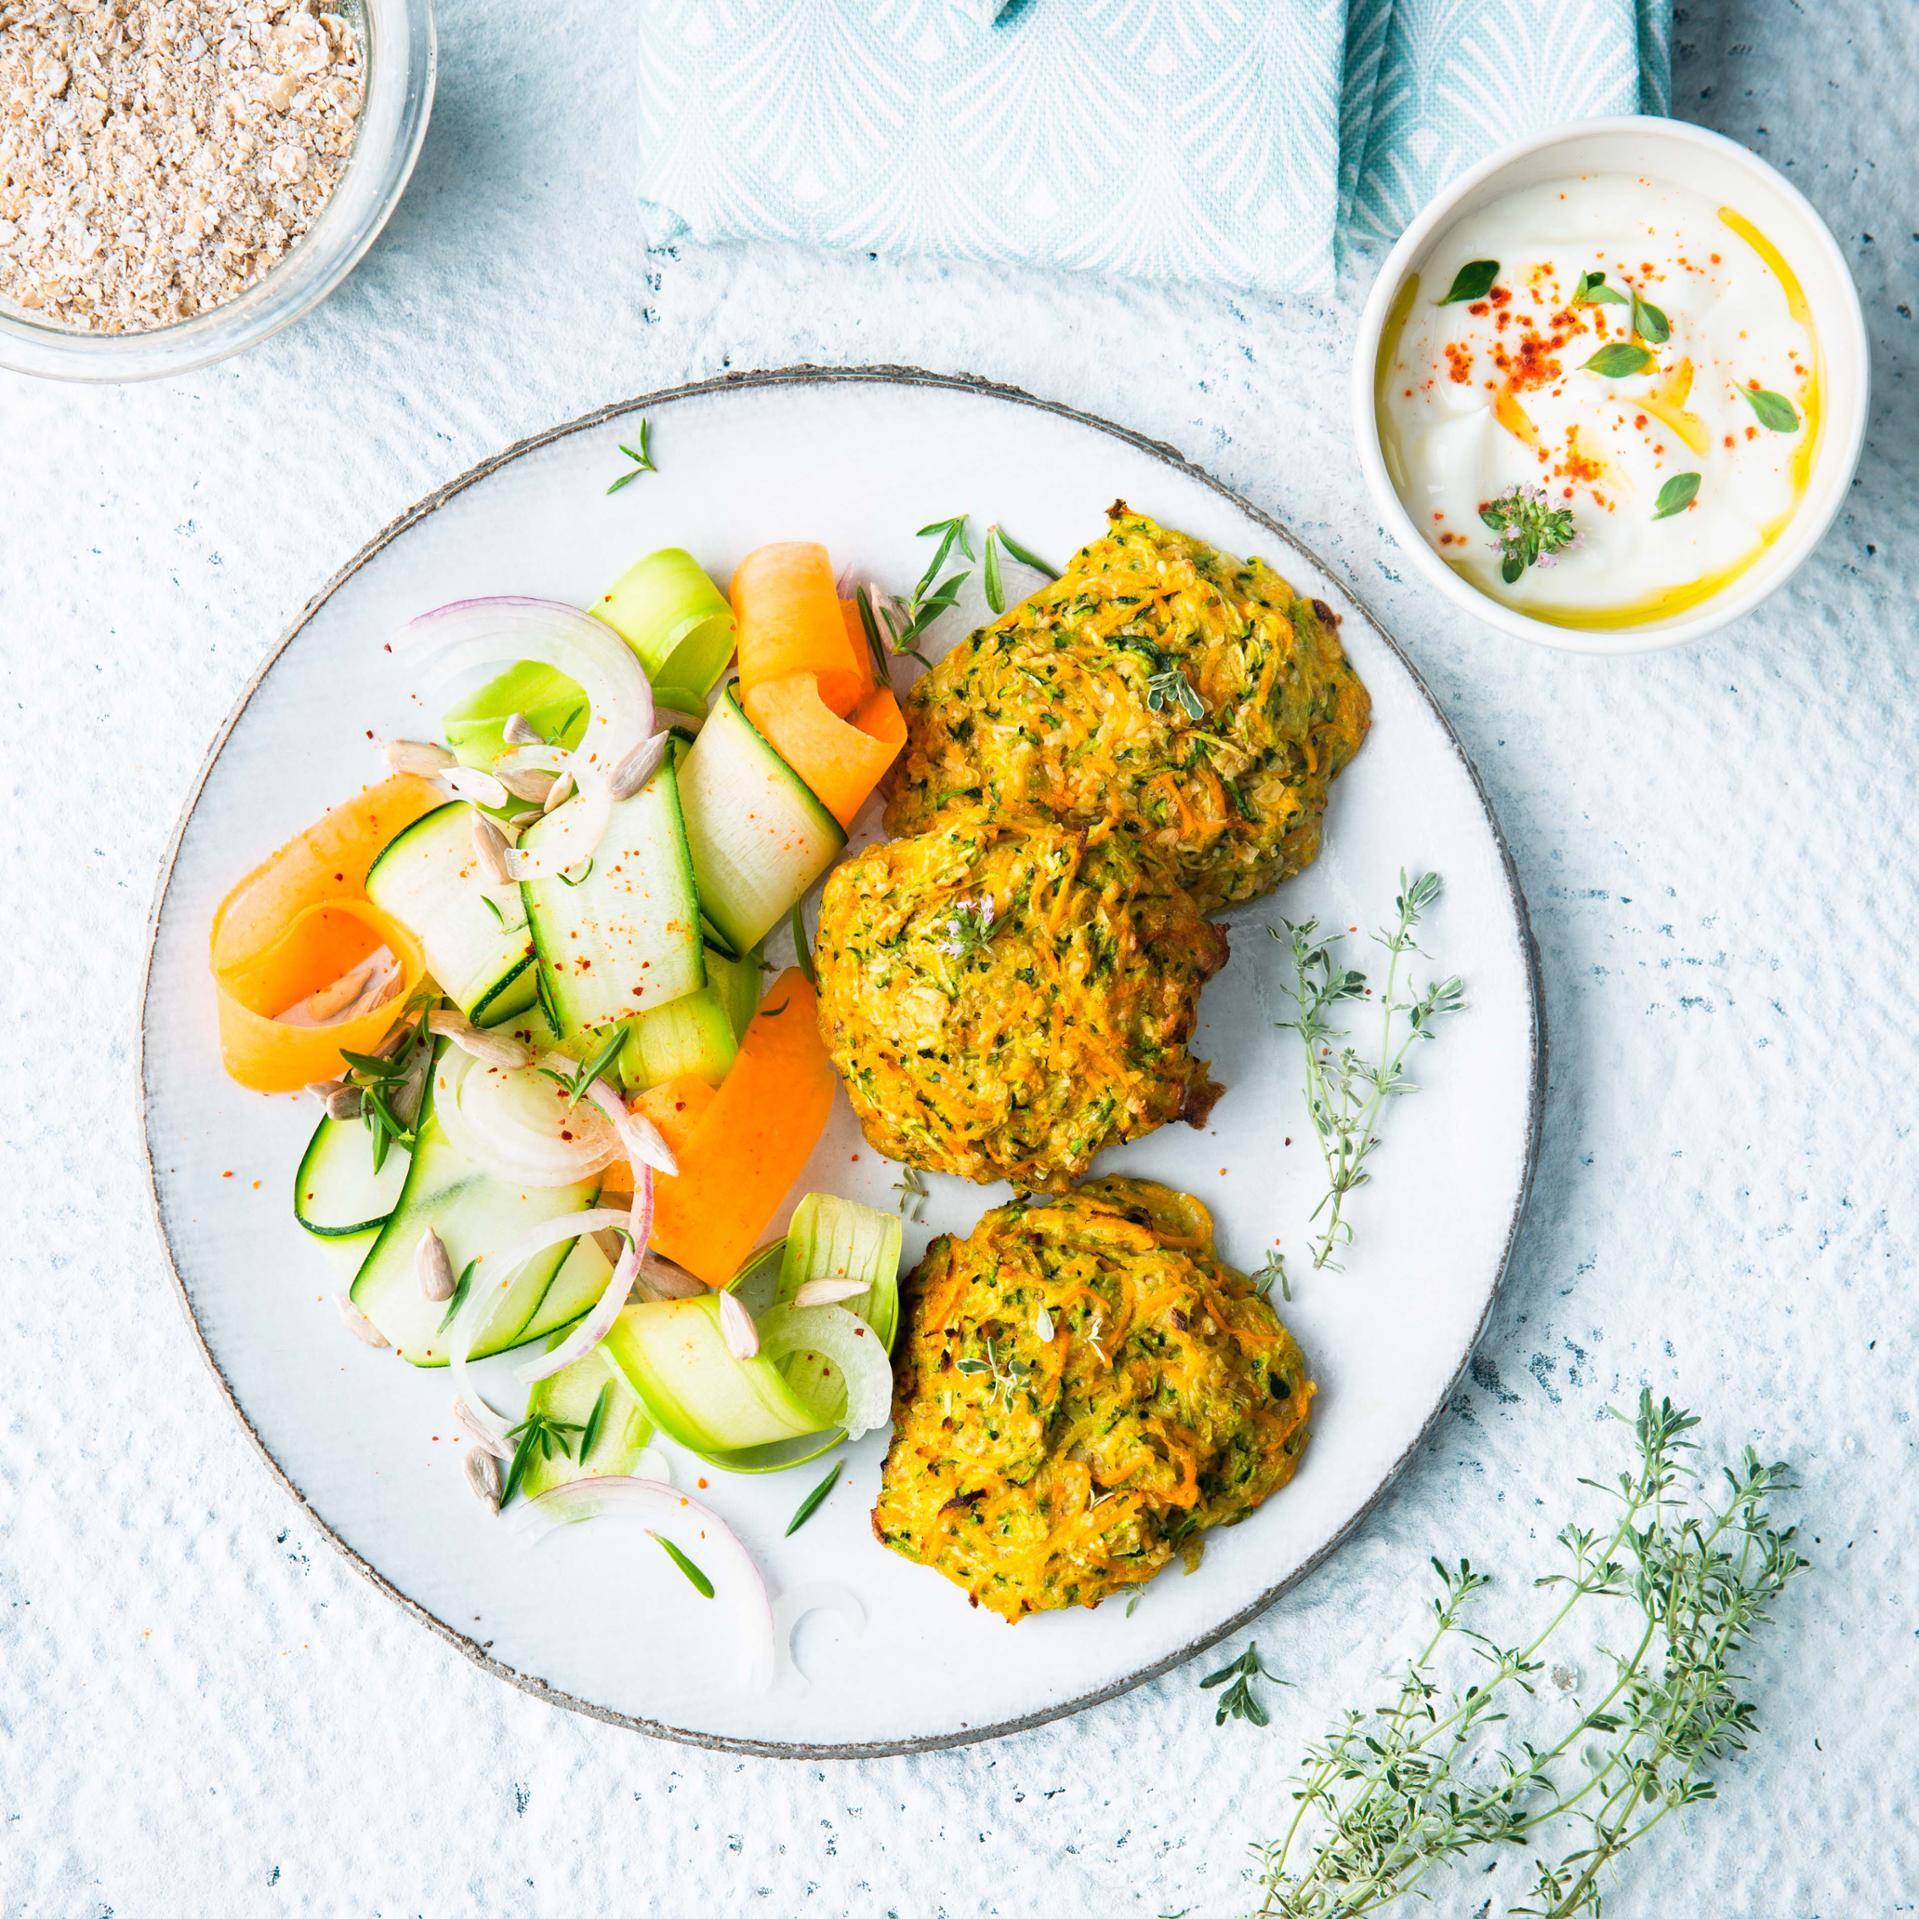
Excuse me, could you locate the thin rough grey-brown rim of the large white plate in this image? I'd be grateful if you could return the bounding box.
[132,363,1549,1760]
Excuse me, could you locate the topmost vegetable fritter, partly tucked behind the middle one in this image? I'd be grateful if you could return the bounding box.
[887,503,1372,910]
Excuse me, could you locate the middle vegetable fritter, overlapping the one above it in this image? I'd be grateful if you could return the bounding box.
[814,812,1226,1192]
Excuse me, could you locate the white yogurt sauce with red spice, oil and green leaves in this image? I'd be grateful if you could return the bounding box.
[1378,173,1819,628]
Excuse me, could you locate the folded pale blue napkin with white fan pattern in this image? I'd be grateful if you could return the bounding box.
[639,0,1671,294]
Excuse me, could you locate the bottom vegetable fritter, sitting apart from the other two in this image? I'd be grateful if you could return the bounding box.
[873,1178,1315,1620]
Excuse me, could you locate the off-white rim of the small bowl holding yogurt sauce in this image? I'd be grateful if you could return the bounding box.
[1351,113,1871,654]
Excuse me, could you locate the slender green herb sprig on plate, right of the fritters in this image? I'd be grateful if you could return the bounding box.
[1267,869,1466,1272]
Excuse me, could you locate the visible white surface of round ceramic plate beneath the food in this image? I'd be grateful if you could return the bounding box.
[142,368,1545,1754]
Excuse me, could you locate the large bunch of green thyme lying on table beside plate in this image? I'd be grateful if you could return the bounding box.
[1255,1391,1808,1919]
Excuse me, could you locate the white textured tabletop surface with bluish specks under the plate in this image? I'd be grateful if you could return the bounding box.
[0,0,1919,1919]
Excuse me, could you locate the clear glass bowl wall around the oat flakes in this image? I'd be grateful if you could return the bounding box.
[0,0,438,380]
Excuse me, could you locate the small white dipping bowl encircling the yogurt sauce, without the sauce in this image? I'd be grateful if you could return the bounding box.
[1353,113,1871,652]
